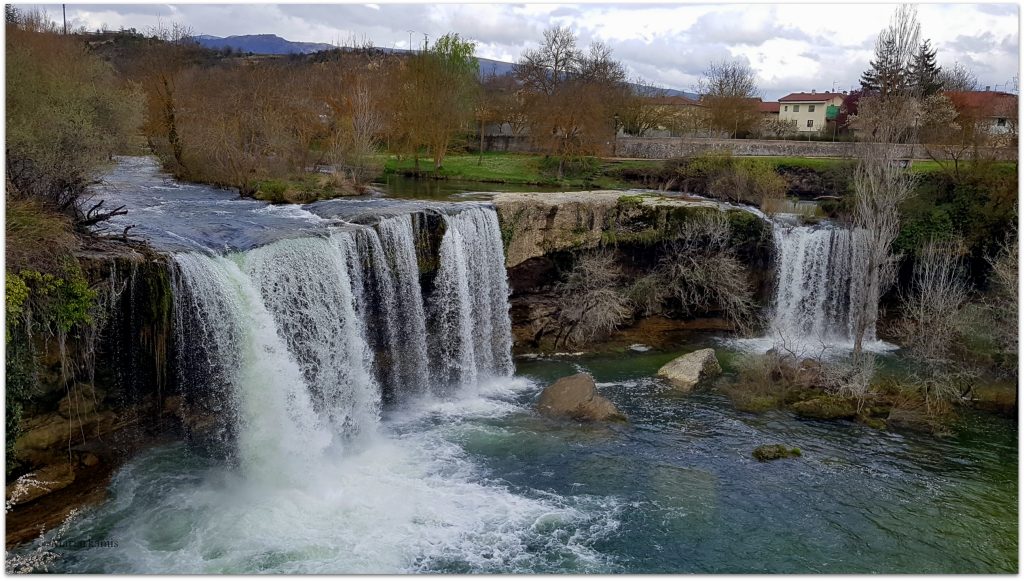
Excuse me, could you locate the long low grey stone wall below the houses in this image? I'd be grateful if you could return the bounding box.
[615,137,1017,161]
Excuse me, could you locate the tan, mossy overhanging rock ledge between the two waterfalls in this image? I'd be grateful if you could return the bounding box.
[494,191,773,352]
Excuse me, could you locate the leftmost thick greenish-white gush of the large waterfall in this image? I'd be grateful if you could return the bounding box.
[175,253,331,482]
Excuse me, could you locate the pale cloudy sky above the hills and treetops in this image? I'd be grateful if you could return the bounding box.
[32,3,1019,99]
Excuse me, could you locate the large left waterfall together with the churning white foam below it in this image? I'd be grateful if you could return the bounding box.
[56,207,616,573]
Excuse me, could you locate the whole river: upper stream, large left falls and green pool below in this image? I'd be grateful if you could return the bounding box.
[25,160,1018,574]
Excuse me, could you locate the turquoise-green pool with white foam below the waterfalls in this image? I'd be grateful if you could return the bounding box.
[39,351,1018,573]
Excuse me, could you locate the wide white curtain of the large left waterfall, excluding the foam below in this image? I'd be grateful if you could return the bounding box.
[173,206,513,469]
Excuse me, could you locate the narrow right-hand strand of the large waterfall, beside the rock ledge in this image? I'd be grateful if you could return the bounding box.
[432,207,513,383]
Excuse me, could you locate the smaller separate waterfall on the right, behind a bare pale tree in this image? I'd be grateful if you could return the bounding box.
[772,224,874,343]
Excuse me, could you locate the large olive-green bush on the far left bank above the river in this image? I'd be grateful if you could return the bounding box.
[6,25,142,220]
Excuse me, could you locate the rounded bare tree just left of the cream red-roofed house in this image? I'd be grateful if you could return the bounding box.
[697,60,760,137]
